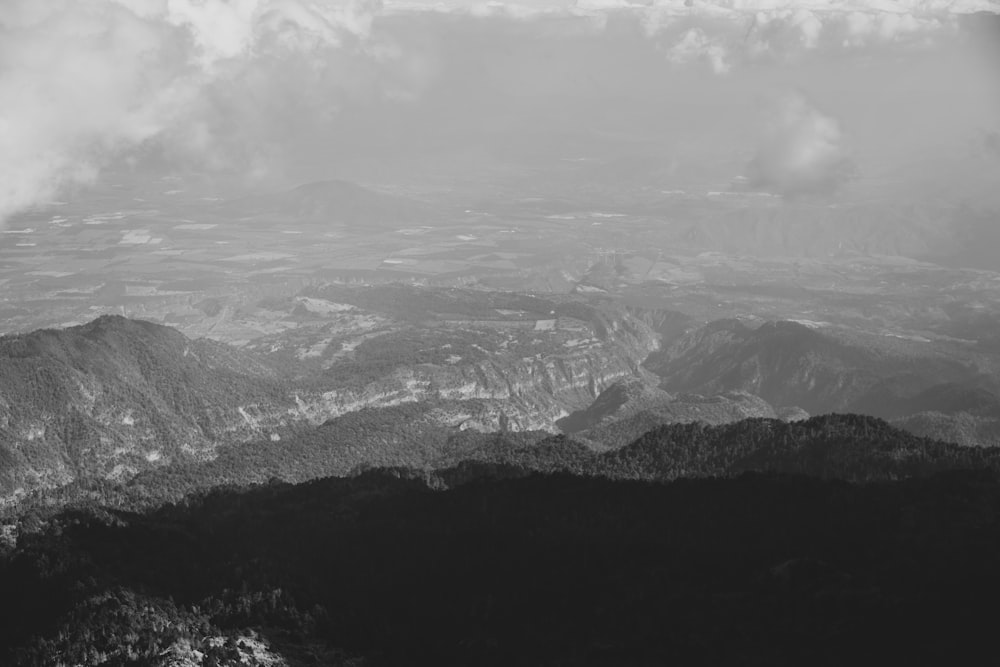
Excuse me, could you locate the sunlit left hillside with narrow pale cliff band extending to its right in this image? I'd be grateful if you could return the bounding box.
[0,312,657,496]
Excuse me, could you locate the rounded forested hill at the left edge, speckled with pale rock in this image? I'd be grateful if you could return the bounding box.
[0,316,288,495]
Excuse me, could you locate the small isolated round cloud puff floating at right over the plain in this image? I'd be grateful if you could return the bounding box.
[747,93,854,197]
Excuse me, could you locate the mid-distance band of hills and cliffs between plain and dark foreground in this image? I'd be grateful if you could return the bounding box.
[0,297,1000,504]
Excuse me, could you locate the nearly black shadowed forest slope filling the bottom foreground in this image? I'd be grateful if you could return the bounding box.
[0,471,1000,665]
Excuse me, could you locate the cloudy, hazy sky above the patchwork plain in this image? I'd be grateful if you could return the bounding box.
[0,0,1000,220]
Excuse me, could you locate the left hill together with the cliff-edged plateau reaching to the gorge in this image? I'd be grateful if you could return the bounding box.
[0,287,657,496]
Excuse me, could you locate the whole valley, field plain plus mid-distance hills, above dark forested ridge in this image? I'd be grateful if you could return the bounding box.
[0,175,1000,502]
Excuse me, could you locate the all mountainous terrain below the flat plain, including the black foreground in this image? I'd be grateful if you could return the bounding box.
[0,306,1000,667]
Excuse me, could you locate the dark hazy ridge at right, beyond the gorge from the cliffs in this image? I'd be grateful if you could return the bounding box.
[646,320,1000,418]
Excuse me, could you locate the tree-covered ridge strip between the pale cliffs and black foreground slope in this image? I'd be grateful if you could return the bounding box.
[6,410,1000,515]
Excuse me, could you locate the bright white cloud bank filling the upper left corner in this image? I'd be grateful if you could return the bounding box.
[0,0,380,221]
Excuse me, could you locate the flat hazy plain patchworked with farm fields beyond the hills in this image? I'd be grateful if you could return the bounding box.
[0,181,1000,352]
